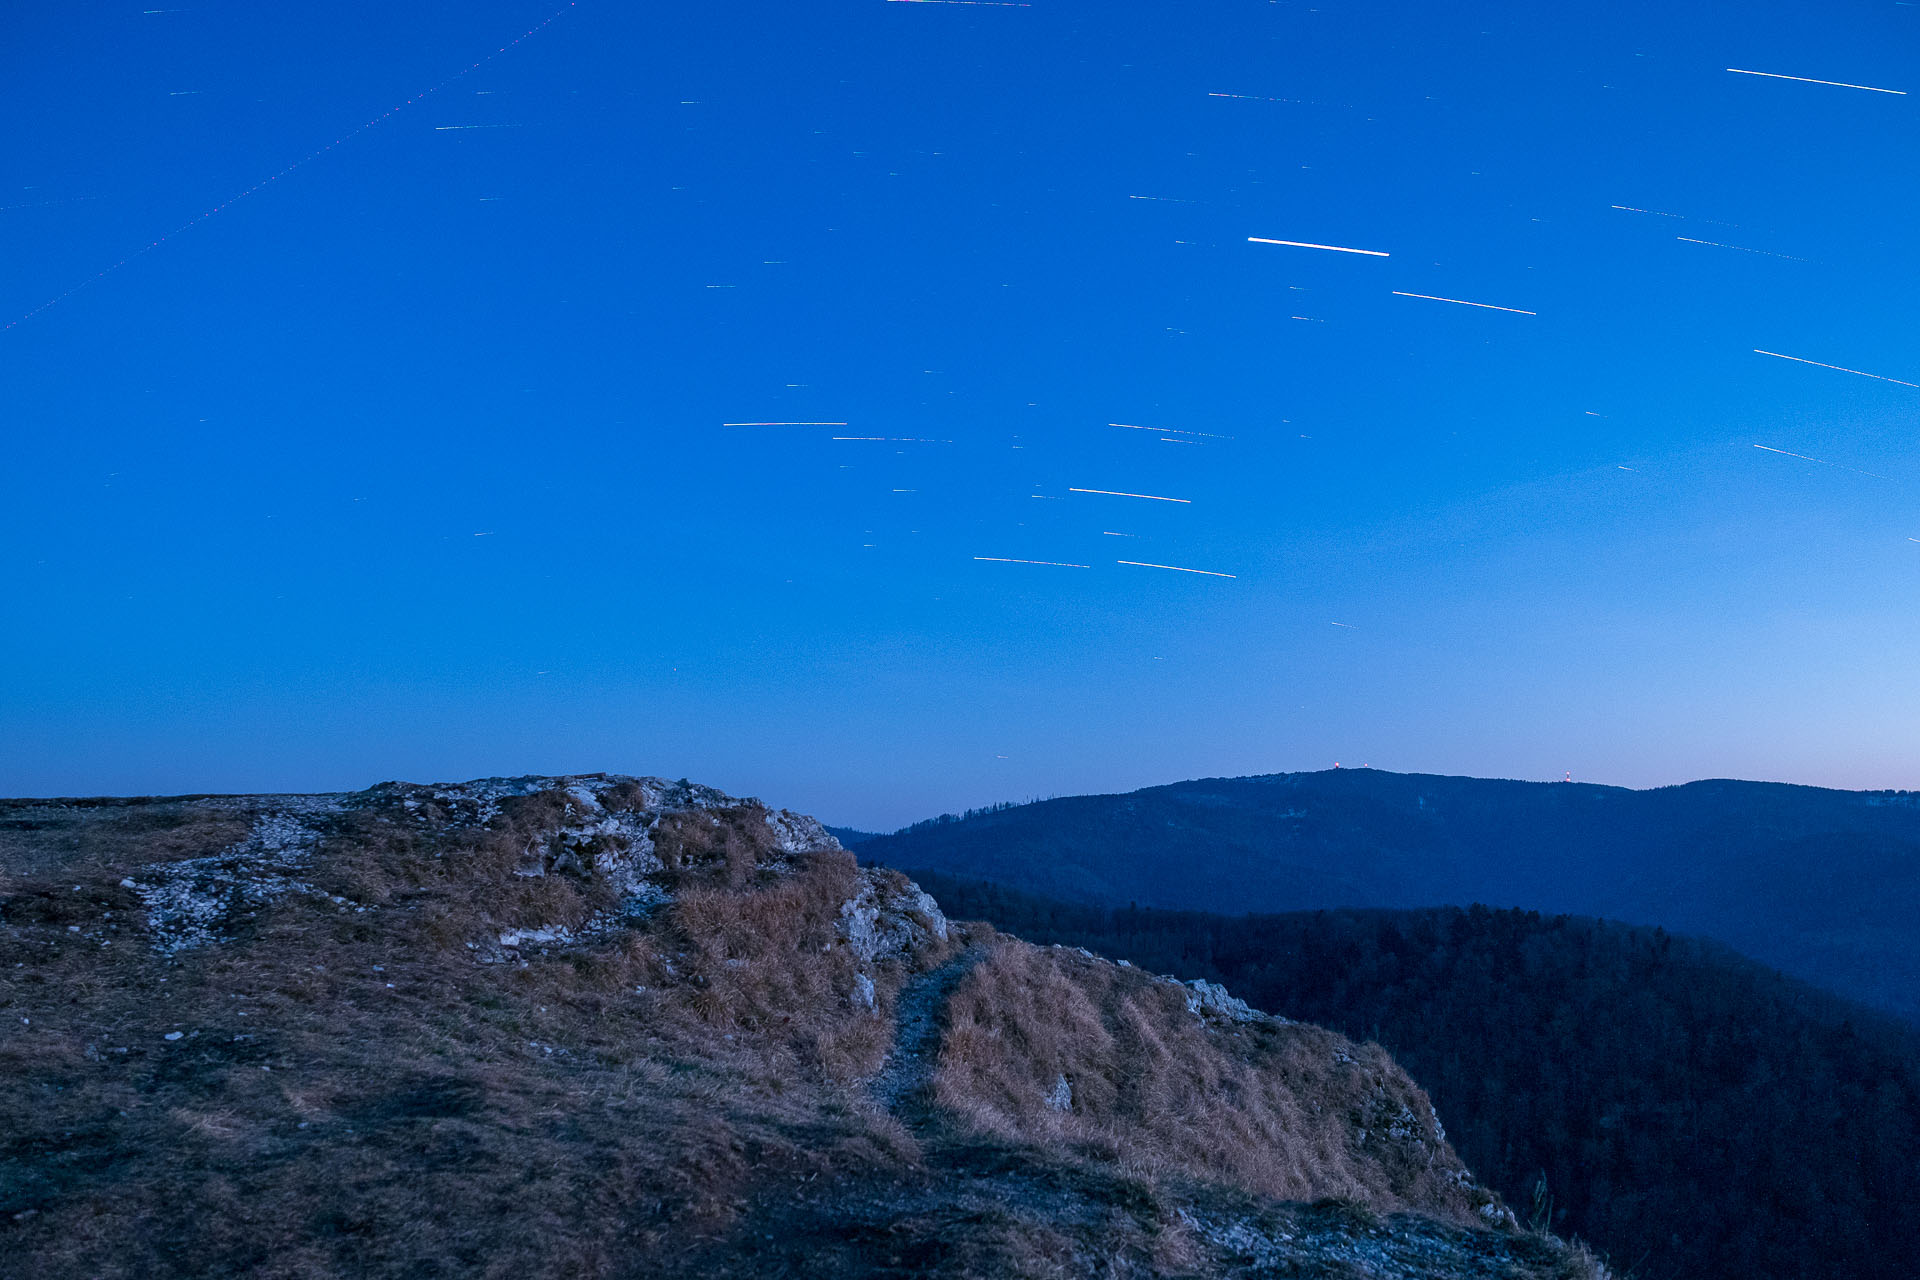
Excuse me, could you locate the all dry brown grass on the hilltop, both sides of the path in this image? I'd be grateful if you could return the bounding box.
[0,793,1589,1280]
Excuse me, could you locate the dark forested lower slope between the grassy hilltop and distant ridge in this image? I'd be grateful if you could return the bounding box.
[908,871,1920,1280]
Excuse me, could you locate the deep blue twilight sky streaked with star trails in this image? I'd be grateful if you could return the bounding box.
[0,0,1920,827]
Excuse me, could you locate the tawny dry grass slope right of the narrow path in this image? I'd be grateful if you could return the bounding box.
[935,938,1492,1221]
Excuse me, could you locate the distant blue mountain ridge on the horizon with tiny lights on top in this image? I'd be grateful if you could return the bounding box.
[858,770,1920,1021]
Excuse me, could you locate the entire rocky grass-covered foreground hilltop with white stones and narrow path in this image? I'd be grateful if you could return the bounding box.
[0,775,1603,1280]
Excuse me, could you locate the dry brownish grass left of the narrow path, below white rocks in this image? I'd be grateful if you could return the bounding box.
[0,794,910,1276]
